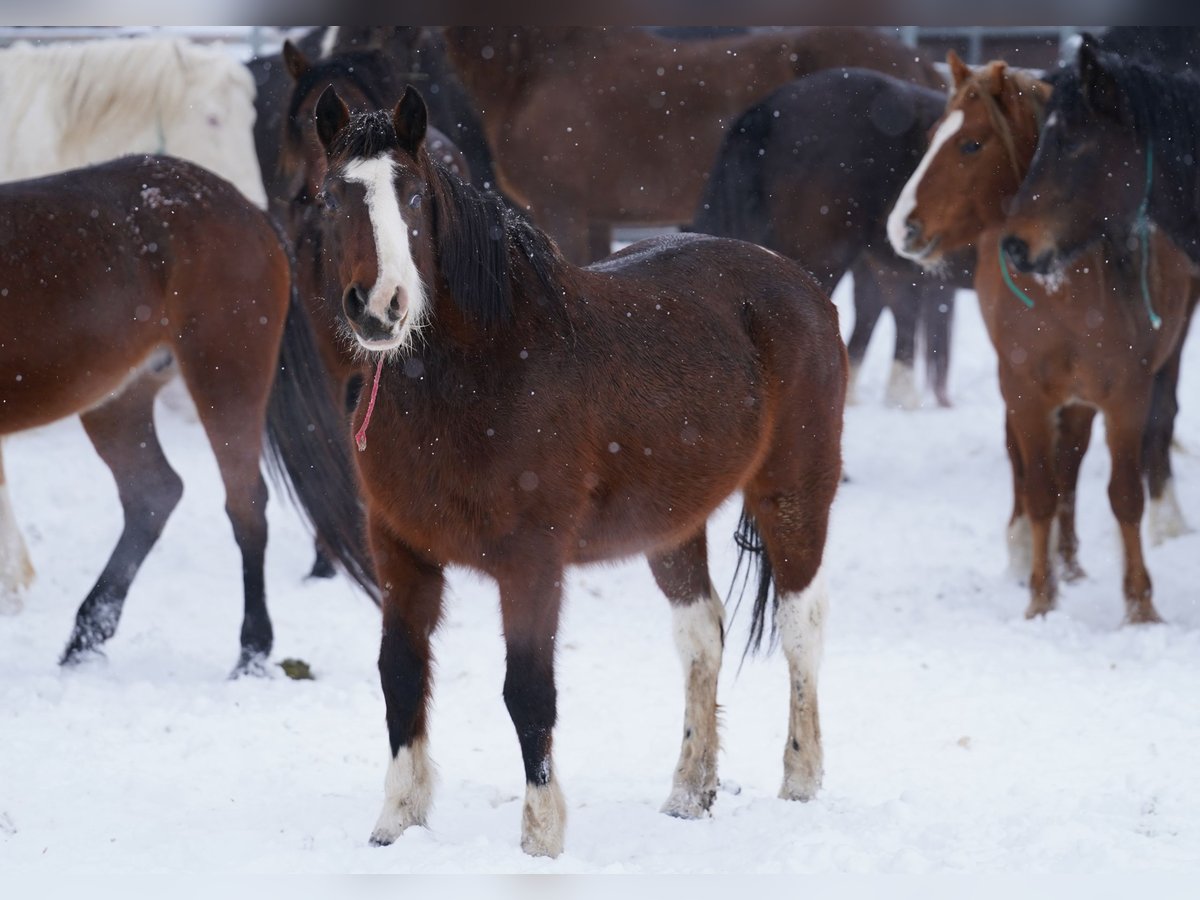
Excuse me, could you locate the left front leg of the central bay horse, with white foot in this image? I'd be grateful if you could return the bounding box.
[370,520,444,846]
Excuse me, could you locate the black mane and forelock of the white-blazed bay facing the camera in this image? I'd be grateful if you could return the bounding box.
[331,110,566,328]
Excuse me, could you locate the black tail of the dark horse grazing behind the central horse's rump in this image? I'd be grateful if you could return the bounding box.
[690,103,775,244]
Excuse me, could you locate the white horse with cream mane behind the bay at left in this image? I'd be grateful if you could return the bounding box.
[0,37,266,613]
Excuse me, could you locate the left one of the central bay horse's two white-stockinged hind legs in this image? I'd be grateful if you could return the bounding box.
[648,530,725,818]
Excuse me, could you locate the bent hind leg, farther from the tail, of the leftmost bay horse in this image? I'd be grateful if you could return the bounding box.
[61,376,184,665]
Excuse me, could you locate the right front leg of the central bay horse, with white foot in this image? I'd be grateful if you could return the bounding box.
[497,551,566,857]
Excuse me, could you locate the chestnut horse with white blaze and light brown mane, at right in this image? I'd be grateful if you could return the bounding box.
[888,52,1196,623]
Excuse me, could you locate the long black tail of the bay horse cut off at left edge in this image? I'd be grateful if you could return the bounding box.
[266,283,379,604]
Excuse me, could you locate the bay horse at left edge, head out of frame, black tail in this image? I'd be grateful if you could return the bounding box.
[0,156,373,676]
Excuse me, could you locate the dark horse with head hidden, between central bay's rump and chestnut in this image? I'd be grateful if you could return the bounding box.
[691,68,971,408]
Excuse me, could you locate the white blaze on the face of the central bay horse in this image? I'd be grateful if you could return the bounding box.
[342,154,426,350]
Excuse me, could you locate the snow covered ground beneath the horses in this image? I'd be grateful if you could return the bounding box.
[0,282,1200,875]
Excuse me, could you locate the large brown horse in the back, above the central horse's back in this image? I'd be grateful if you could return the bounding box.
[443,25,941,264]
